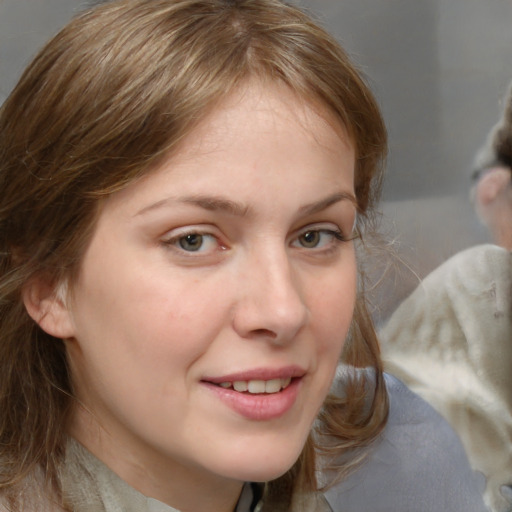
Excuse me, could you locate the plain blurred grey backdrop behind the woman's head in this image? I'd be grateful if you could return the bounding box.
[0,0,512,319]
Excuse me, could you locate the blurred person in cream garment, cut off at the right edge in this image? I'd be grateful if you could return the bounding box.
[381,80,512,512]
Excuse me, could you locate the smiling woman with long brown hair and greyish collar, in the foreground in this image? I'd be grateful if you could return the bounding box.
[0,0,488,512]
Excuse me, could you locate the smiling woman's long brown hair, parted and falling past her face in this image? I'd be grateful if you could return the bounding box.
[0,0,387,508]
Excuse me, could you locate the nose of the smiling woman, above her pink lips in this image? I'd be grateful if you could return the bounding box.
[233,248,308,344]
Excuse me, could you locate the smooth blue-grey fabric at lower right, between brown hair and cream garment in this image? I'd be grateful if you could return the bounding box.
[325,375,486,512]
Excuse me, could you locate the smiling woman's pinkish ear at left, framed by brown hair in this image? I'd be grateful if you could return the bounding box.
[21,277,74,339]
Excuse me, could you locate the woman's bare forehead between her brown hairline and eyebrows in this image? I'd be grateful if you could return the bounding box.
[102,83,355,216]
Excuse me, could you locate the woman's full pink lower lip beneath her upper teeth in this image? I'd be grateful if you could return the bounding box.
[203,378,302,421]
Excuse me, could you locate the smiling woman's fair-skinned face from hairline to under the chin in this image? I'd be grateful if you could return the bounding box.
[62,84,356,504]
